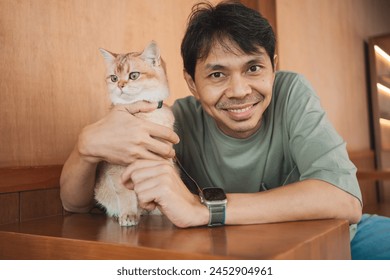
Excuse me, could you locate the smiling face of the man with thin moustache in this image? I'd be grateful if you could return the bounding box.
[185,40,275,138]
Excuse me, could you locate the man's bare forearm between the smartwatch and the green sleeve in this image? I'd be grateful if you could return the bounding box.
[226,180,361,224]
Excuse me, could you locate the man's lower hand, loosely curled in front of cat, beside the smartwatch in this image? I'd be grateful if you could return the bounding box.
[122,160,209,228]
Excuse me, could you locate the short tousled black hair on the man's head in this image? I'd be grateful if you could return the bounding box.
[181,1,276,79]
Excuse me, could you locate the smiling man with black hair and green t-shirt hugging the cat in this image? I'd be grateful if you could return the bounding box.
[61,2,383,257]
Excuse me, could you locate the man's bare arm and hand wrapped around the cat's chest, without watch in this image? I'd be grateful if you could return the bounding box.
[60,102,179,212]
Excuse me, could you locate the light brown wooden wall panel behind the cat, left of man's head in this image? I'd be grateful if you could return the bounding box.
[0,0,216,167]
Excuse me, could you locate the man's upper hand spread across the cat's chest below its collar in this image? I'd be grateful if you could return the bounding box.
[78,102,179,165]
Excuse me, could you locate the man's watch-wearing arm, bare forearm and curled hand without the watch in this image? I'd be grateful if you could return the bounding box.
[122,160,362,227]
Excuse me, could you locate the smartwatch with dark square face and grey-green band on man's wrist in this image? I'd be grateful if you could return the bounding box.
[199,187,227,227]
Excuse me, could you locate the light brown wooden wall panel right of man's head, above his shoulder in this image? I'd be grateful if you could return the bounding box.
[276,0,390,151]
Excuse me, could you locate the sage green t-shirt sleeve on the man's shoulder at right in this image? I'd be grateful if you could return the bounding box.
[286,76,362,203]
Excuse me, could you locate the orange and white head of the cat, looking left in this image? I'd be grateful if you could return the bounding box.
[100,41,169,105]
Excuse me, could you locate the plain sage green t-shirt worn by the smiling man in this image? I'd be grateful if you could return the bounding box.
[173,71,362,201]
